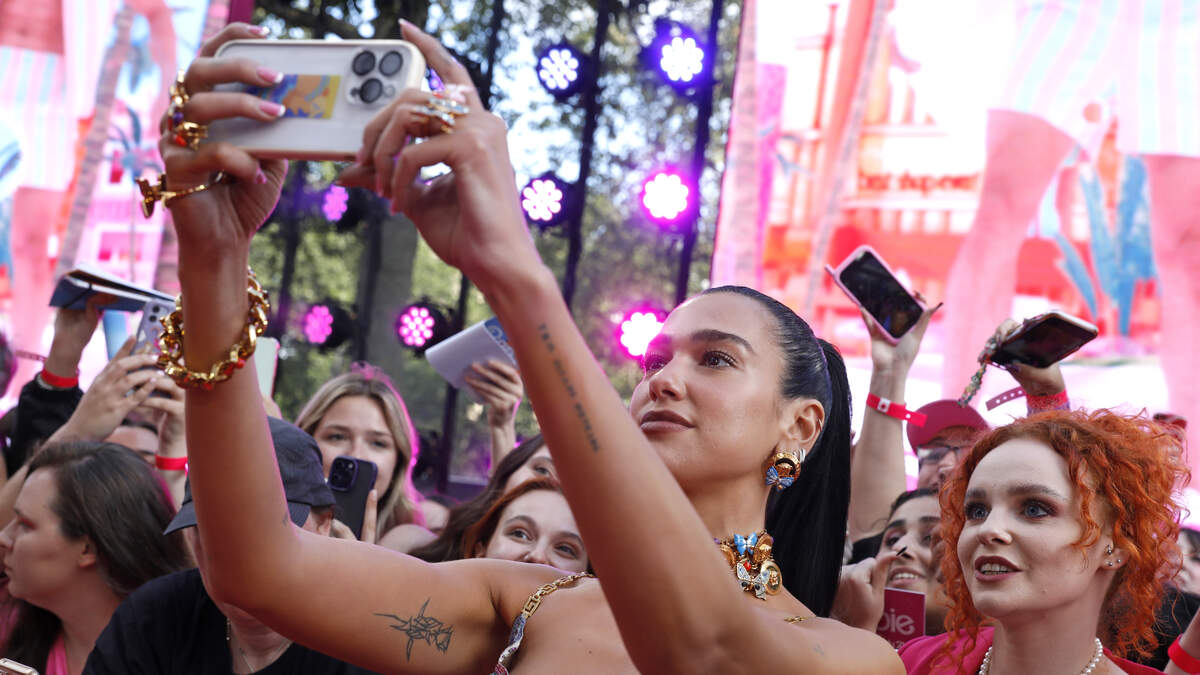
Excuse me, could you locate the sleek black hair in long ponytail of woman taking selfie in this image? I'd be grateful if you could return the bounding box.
[703,286,850,616]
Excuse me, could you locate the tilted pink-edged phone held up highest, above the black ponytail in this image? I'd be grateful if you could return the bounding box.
[826,245,925,345]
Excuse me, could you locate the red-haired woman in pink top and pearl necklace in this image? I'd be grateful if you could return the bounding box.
[900,411,1186,675]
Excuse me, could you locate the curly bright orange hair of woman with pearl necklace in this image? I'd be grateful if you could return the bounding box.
[941,410,1188,671]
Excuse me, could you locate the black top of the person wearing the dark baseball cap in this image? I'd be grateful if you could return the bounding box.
[83,569,371,675]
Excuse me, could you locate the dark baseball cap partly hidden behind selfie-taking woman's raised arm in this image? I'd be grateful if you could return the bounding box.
[163,417,334,534]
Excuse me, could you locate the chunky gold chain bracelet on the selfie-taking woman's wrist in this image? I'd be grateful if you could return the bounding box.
[158,268,271,390]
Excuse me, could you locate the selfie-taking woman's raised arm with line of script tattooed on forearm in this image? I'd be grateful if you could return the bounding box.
[338,24,899,673]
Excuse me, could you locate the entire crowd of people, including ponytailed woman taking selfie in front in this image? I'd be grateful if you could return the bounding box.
[0,19,1200,675]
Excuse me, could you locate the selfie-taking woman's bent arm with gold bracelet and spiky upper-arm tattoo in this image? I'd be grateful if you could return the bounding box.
[160,24,537,674]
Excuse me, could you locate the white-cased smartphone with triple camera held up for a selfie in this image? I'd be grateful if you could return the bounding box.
[208,40,425,161]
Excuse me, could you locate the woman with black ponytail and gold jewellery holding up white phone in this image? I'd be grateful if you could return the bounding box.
[160,23,901,674]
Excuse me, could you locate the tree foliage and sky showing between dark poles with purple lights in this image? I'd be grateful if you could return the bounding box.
[244,0,740,482]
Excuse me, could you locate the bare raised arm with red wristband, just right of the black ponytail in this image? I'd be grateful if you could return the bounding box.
[850,305,941,542]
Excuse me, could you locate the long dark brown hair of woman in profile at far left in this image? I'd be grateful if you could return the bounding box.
[2,441,191,673]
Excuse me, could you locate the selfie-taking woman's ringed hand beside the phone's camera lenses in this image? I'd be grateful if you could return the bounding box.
[340,22,544,292]
